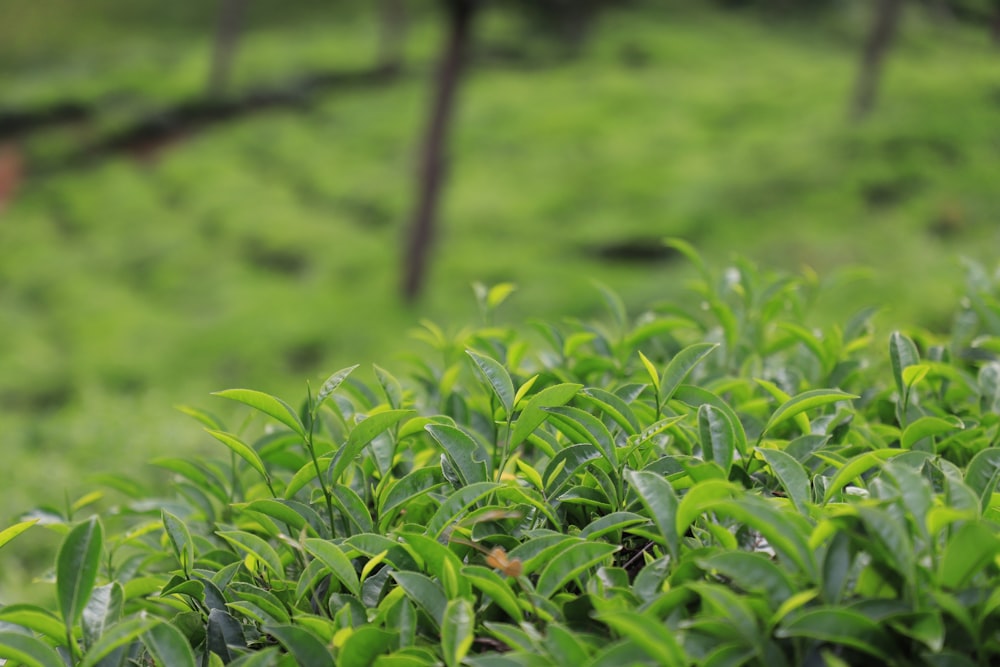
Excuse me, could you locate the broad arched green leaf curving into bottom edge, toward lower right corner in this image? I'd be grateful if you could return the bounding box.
[775,608,895,663]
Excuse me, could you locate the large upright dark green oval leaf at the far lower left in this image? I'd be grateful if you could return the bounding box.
[56,517,104,630]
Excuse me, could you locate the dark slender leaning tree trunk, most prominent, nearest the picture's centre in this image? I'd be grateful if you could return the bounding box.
[403,0,477,302]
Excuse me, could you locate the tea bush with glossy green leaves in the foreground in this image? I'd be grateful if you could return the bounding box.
[0,243,1000,667]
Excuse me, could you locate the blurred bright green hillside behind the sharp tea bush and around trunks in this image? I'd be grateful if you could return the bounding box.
[0,0,1000,596]
